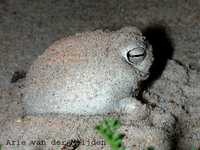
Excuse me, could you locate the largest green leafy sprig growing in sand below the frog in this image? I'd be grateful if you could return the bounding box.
[94,116,125,150]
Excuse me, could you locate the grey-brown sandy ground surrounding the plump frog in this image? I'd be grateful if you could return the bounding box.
[0,0,200,150]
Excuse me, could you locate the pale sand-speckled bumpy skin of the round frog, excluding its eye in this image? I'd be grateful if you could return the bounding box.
[24,27,153,115]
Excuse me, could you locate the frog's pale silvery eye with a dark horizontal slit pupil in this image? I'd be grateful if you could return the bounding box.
[127,47,146,64]
